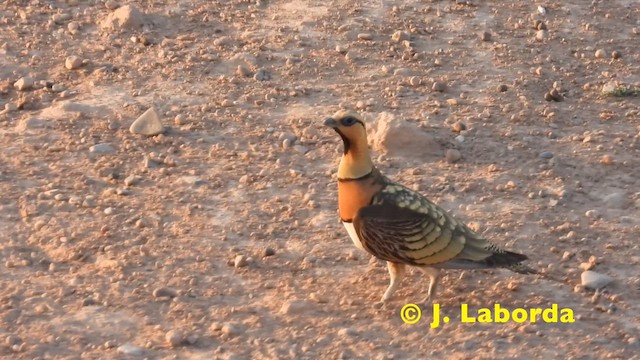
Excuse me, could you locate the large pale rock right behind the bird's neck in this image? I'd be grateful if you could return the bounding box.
[369,112,442,160]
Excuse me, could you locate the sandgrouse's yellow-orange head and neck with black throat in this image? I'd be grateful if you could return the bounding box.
[324,110,373,179]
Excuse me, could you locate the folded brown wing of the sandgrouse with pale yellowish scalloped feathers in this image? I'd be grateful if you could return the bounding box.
[353,185,527,268]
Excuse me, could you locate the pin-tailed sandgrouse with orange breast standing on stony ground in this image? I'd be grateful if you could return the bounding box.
[324,111,534,303]
